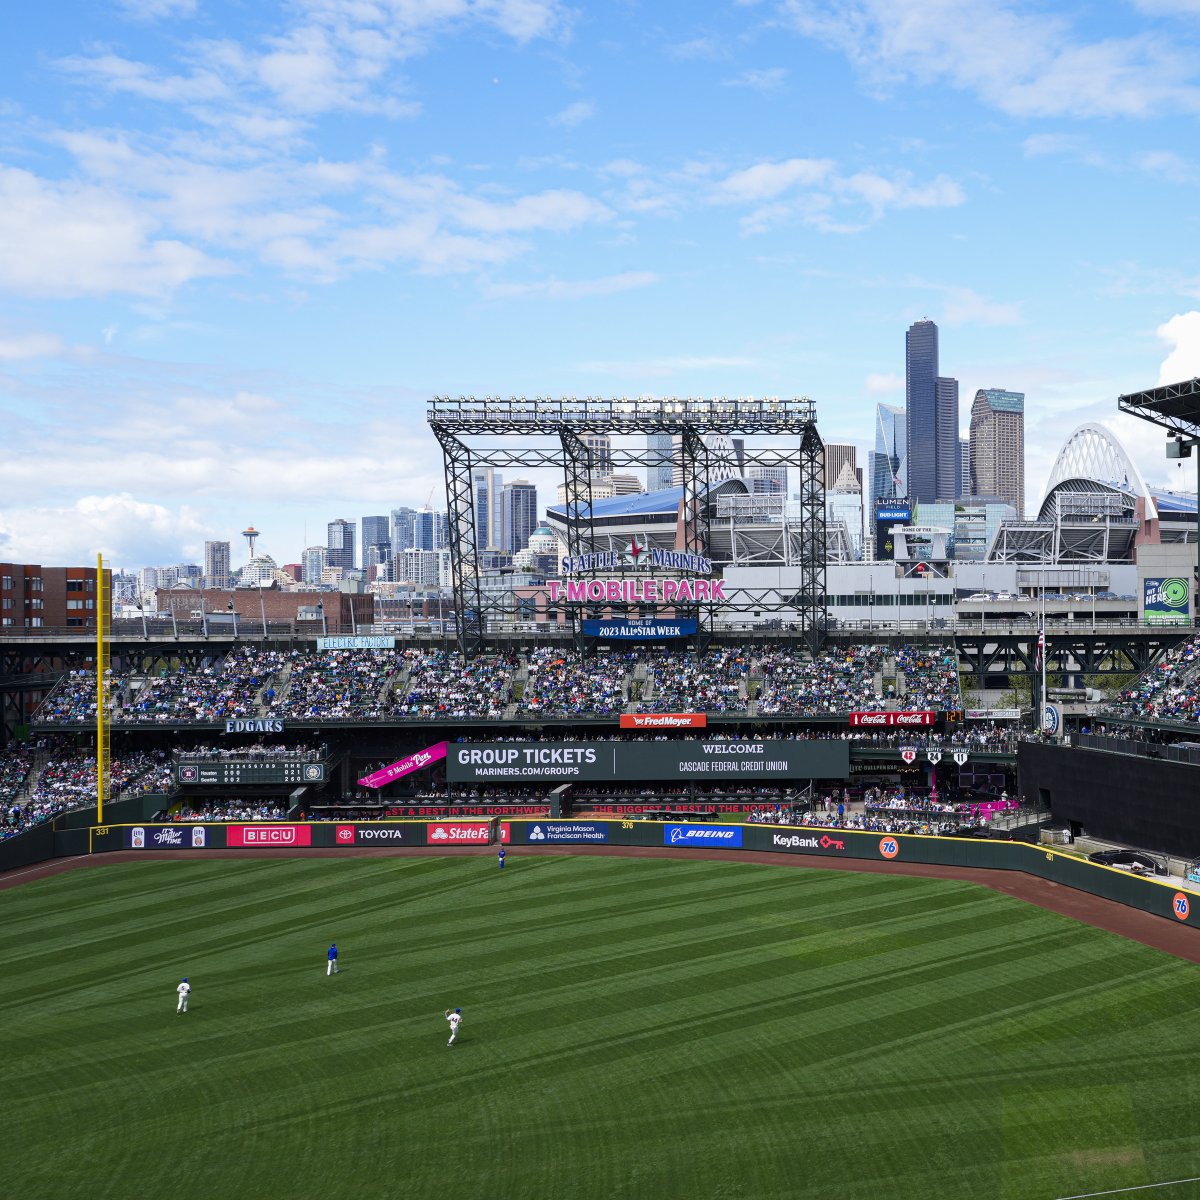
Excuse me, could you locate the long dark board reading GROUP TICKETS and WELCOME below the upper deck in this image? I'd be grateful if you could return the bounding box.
[446,740,850,784]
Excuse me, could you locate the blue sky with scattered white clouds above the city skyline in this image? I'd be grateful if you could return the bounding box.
[0,0,1200,568]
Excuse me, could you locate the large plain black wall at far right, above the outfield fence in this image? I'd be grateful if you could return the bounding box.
[1018,742,1200,858]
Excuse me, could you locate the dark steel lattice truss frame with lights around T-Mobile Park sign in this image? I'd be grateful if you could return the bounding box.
[428,396,827,658]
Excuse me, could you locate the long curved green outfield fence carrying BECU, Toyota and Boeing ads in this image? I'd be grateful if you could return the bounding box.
[63,817,1200,926]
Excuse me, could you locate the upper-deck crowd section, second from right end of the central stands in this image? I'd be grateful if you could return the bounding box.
[757,646,884,715]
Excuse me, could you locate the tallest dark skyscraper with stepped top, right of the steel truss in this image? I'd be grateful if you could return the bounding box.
[905,320,960,502]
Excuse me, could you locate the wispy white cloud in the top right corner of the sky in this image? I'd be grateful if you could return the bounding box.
[782,0,1200,116]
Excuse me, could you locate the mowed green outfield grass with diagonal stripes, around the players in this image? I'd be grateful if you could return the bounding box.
[0,852,1200,1200]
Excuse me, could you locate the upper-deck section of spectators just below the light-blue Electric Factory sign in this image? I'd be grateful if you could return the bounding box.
[264,650,398,721]
